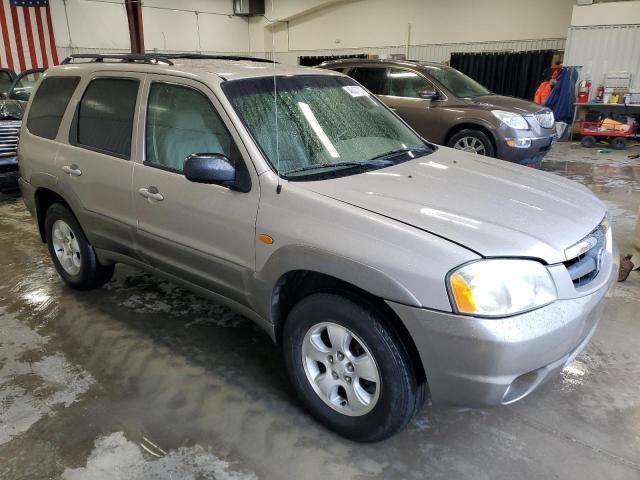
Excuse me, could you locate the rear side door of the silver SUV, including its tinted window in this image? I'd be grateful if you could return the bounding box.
[56,72,144,256]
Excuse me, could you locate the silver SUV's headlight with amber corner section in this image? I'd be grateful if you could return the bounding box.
[448,259,557,317]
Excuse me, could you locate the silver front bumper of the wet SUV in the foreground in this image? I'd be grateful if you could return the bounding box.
[389,276,610,407]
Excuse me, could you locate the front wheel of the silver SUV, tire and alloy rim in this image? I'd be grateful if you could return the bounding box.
[283,293,425,442]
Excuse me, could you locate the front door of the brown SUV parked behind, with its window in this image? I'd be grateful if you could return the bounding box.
[380,67,441,141]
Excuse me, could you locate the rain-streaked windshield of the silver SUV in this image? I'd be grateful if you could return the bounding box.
[223,75,431,180]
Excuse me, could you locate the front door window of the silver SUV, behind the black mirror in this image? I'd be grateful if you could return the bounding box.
[144,82,233,172]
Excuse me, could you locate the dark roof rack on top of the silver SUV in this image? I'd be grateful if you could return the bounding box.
[62,53,278,65]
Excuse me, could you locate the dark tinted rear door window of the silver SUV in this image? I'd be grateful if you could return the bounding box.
[74,78,138,159]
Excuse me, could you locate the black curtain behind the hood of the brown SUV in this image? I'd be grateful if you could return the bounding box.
[450,50,555,100]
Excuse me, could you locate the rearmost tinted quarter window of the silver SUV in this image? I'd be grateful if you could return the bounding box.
[27,77,80,140]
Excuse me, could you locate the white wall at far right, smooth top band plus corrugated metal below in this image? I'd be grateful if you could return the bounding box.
[565,1,640,97]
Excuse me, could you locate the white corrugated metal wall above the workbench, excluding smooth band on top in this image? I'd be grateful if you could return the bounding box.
[564,25,640,95]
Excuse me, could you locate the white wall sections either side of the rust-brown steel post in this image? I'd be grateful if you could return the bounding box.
[51,0,249,58]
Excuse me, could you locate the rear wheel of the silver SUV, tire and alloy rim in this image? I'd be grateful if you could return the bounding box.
[44,203,114,290]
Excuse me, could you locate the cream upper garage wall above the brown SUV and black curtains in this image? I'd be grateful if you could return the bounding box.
[249,0,575,63]
